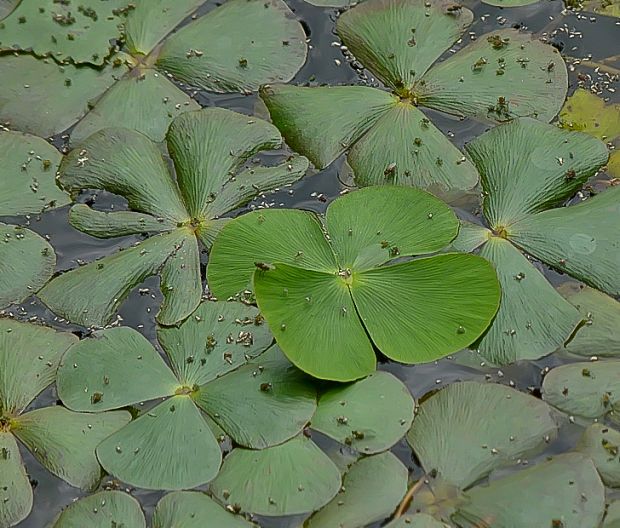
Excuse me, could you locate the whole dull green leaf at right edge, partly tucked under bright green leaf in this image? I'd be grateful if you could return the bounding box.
[454,118,620,364]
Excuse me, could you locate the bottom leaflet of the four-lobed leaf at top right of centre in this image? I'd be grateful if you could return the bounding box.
[348,102,478,194]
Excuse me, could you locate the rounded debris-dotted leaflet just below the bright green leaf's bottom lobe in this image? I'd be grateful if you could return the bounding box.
[311,371,415,454]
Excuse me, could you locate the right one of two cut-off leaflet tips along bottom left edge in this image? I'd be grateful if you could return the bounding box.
[153,491,256,528]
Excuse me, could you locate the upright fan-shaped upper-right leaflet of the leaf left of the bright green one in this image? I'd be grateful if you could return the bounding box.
[166,108,282,218]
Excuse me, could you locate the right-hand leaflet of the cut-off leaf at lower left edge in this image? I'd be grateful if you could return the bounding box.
[12,406,131,490]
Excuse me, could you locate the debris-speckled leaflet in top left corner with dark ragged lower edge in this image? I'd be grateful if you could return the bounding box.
[0,0,130,65]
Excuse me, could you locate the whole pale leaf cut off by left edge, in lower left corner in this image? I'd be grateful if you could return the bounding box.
[0,319,130,527]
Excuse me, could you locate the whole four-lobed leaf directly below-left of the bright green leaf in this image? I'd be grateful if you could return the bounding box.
[58,301,316,489]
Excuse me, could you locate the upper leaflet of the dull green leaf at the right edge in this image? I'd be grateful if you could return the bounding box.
[466,118,608,227]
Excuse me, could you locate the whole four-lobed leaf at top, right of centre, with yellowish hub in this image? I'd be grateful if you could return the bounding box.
[261,0,567,195]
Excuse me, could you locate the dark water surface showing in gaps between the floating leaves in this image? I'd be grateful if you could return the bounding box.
[6,0,620,528]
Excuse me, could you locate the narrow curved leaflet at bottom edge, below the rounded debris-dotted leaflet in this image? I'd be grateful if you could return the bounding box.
[307,452,408,528]
